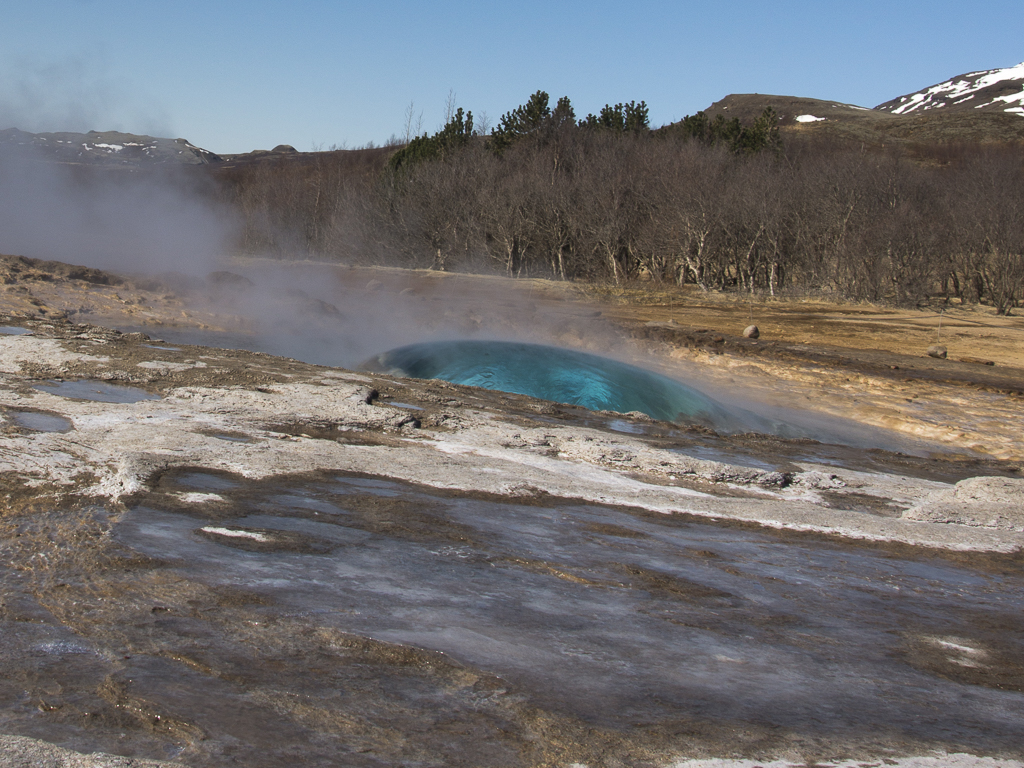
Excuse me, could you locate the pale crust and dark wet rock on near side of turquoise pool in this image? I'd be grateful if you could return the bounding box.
[0,262,1024,766]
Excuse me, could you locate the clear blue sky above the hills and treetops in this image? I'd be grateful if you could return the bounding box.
[0,0,1024,153]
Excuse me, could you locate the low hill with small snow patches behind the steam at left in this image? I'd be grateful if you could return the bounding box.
[0,128,220,168]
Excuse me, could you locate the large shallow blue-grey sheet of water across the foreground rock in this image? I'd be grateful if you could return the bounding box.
[101,471,1024,762]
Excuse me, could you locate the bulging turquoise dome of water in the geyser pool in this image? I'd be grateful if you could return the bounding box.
[365,341,777,432]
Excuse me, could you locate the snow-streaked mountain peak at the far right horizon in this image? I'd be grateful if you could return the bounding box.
[874,62,1024,117]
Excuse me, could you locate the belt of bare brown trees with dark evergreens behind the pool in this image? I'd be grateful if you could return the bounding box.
[216,91,1024,313]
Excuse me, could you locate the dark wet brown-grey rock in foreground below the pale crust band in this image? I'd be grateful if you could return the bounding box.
[0,468,1024,766]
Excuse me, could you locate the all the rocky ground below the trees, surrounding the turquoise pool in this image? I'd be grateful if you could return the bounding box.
[0,257,1024,766]
